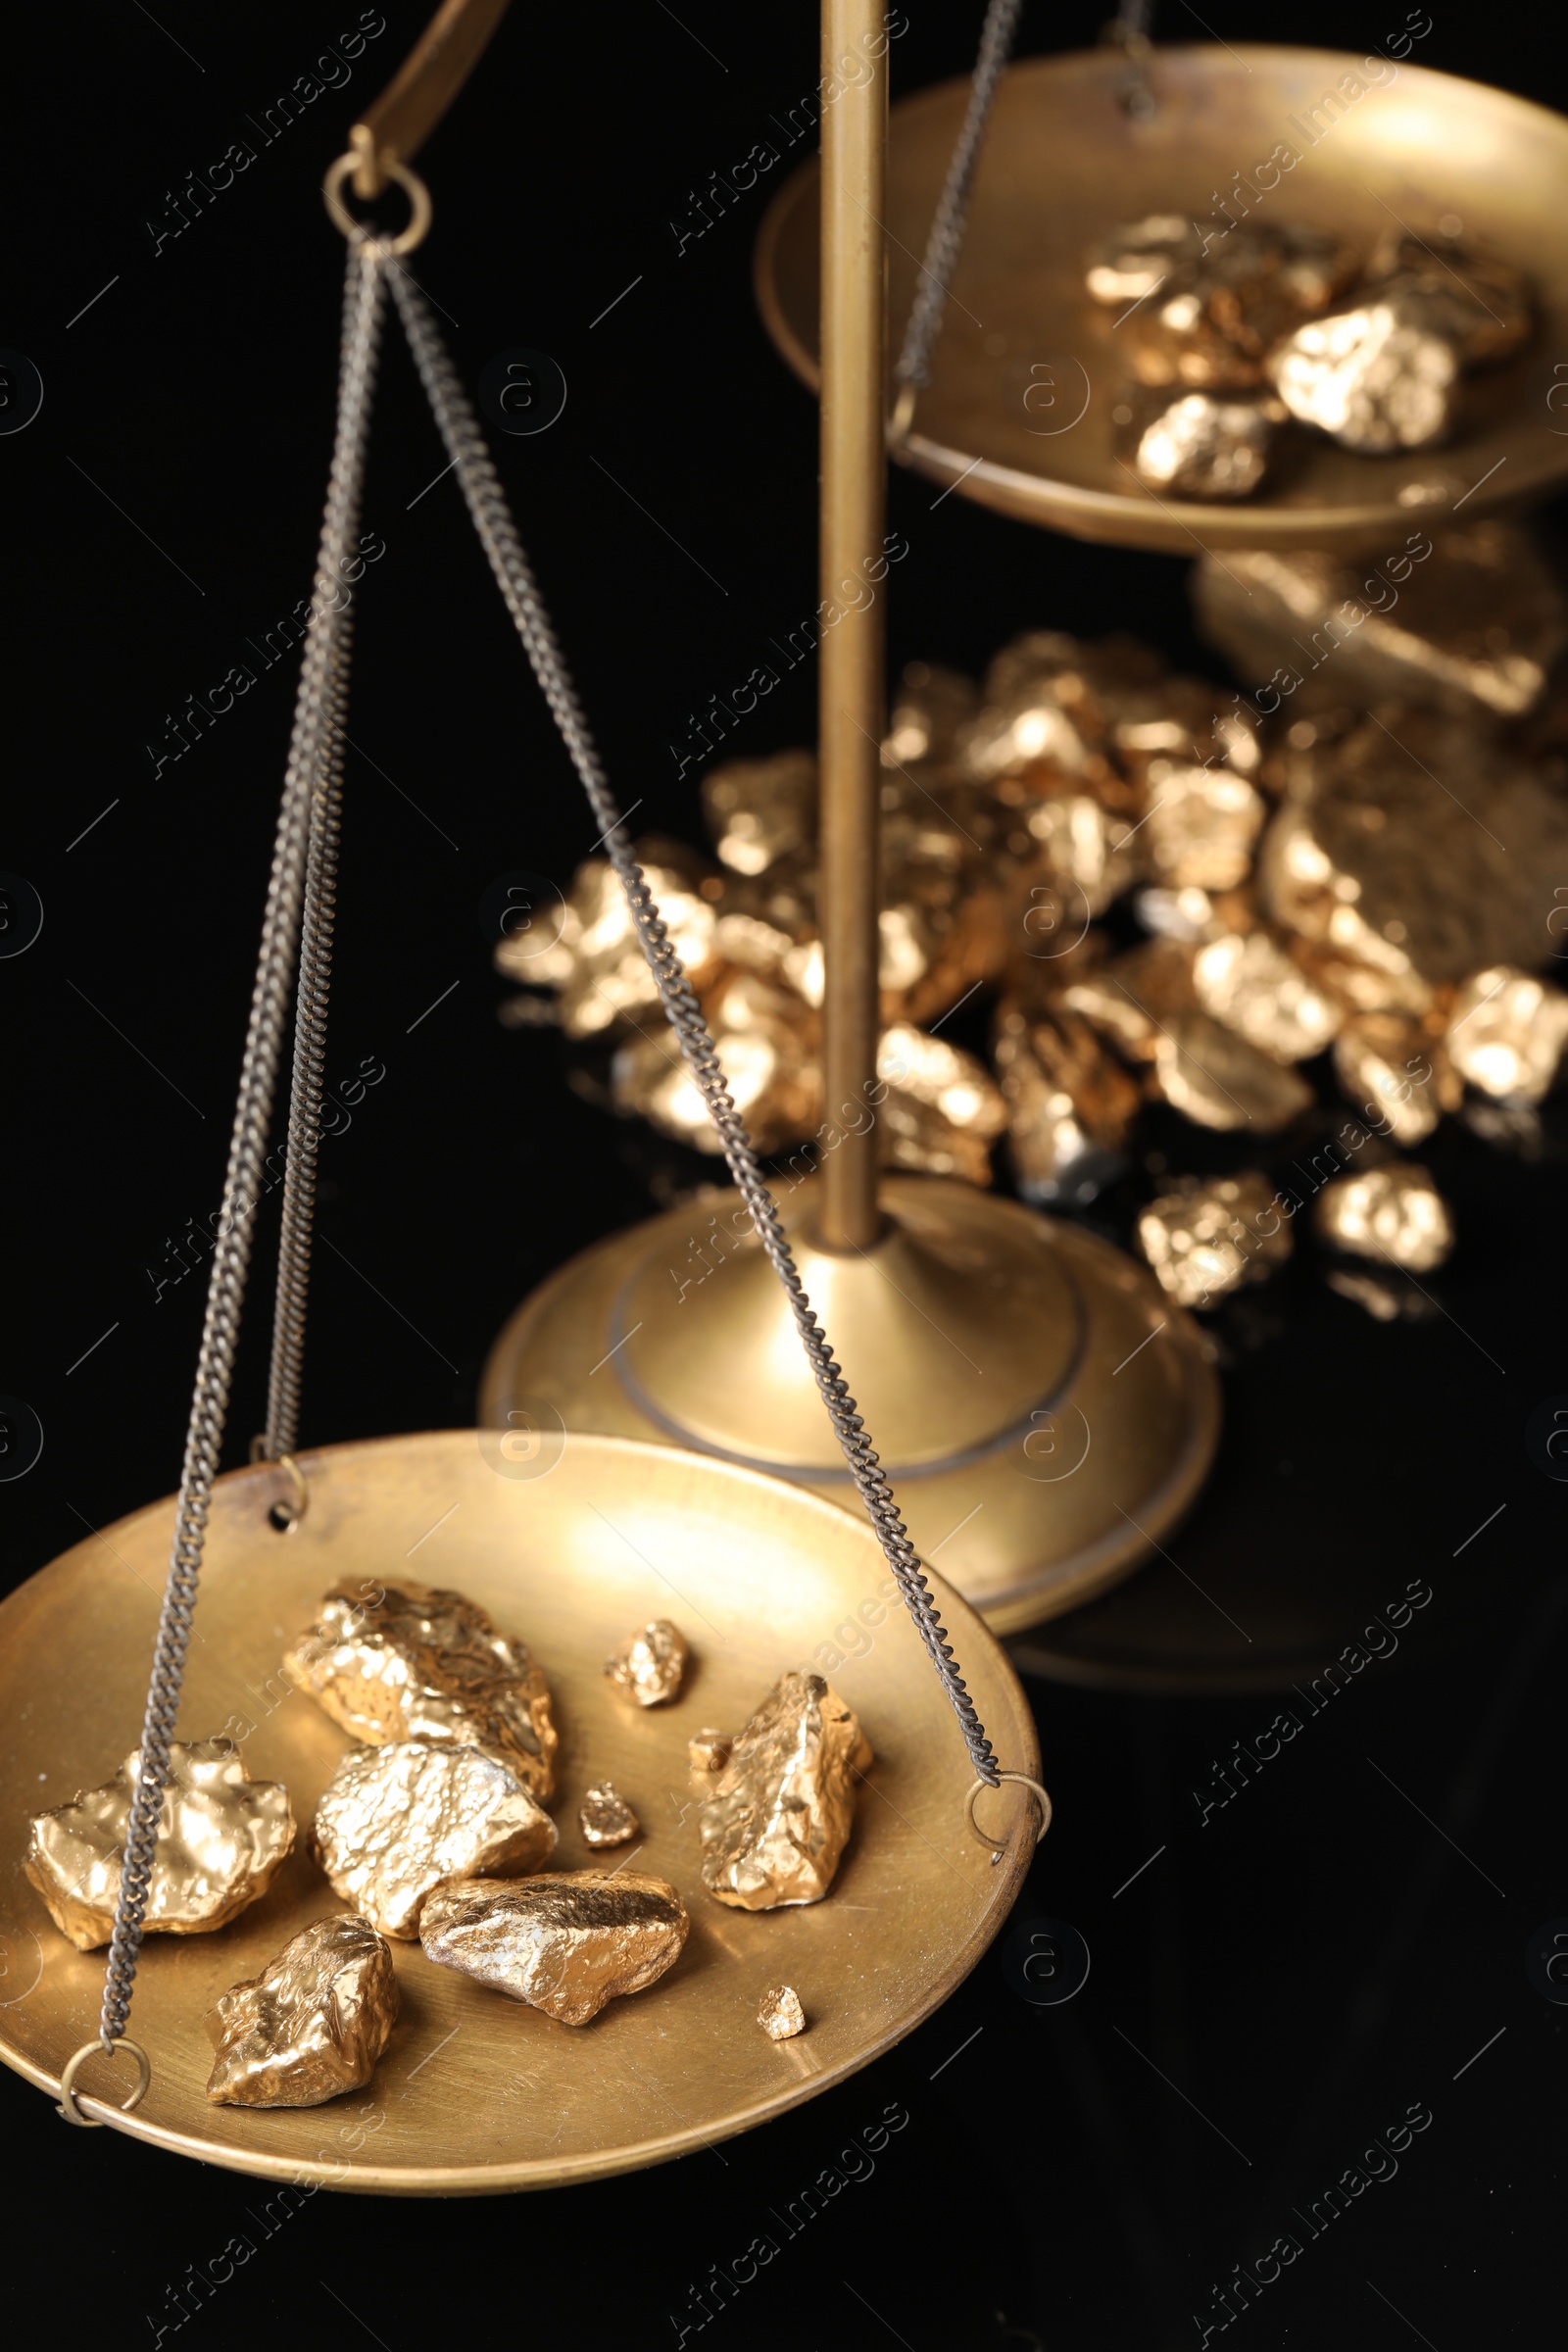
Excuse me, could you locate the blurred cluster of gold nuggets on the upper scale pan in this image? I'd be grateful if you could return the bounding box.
[1086,214,1533,499]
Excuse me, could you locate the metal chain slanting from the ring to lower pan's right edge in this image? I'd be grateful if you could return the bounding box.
[393,269,999,1788]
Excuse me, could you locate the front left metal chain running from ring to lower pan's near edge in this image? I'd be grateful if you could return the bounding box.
[99,240,385,2048]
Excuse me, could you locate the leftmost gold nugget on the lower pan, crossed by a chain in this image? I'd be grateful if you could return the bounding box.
[24,1740,294,1952]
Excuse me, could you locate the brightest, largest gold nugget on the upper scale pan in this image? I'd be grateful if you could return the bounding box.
[1267,287,1460,457]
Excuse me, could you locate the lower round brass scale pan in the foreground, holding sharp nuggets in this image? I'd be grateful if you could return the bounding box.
[0,1430,1039,2194]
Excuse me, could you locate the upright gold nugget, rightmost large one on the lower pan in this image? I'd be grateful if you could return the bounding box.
[701,1672,872,1910]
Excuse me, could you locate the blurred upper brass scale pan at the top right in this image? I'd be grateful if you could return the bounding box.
[757,45,1568,555]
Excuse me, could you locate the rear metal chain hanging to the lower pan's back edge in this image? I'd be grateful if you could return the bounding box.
[261,630,353,1460]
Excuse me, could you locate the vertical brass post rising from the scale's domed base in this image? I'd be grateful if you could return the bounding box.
[818,0,889,1249]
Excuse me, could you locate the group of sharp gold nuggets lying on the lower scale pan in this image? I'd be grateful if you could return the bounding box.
[25,1581,872,2107]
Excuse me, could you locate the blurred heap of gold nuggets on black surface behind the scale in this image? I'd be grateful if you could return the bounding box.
[496,522,1568,1319]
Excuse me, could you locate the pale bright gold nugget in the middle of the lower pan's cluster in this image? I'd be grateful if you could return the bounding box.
[311,1740,555,1942]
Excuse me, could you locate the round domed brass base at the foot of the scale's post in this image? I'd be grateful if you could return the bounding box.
[479,1176,1220,1633]
